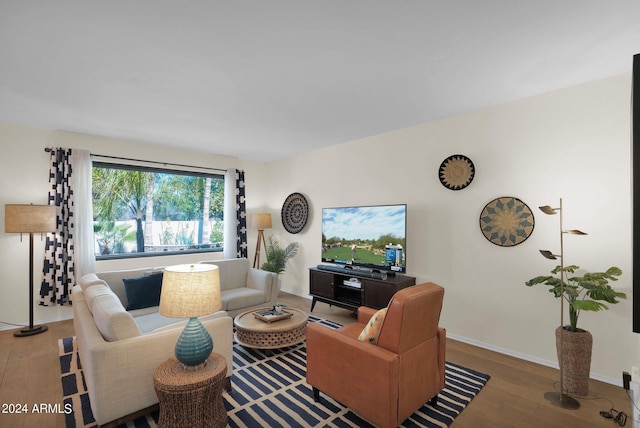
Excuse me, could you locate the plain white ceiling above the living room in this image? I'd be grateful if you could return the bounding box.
[0,0,640,161]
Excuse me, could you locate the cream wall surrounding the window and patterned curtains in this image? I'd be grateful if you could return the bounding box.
[0,123,253,329]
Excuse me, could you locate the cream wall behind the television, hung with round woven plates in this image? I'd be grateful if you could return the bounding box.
[268,75,639,383]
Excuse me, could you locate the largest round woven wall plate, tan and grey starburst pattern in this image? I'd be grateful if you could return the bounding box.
[480,196,535,247]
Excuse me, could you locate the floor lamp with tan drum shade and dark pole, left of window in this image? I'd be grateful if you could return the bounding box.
[4,204,56,337]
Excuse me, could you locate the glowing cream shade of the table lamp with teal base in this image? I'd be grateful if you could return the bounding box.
[160,264,222,318]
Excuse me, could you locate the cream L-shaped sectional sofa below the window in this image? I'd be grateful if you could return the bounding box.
[72,259,279,425]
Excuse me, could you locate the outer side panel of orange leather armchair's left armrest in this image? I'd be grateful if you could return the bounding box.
[307,323,400,420]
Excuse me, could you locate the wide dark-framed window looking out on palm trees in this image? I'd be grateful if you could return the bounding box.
[93,162,224,259]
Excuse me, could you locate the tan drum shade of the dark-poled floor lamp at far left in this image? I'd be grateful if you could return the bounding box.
[4,204,57,233]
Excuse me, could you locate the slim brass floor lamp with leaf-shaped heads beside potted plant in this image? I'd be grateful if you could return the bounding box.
[539,198,586,410]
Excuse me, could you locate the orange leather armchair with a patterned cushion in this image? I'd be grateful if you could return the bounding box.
[307,283,446,428]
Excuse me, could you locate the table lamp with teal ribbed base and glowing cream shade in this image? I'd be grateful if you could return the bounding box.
[160,264,222,370]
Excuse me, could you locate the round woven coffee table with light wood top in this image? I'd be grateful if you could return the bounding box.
[233,308,309,350]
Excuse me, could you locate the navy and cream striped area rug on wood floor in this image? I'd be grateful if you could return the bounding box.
[59,316,489,428]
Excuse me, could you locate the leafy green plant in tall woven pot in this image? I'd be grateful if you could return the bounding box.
[525,265,627,396]
